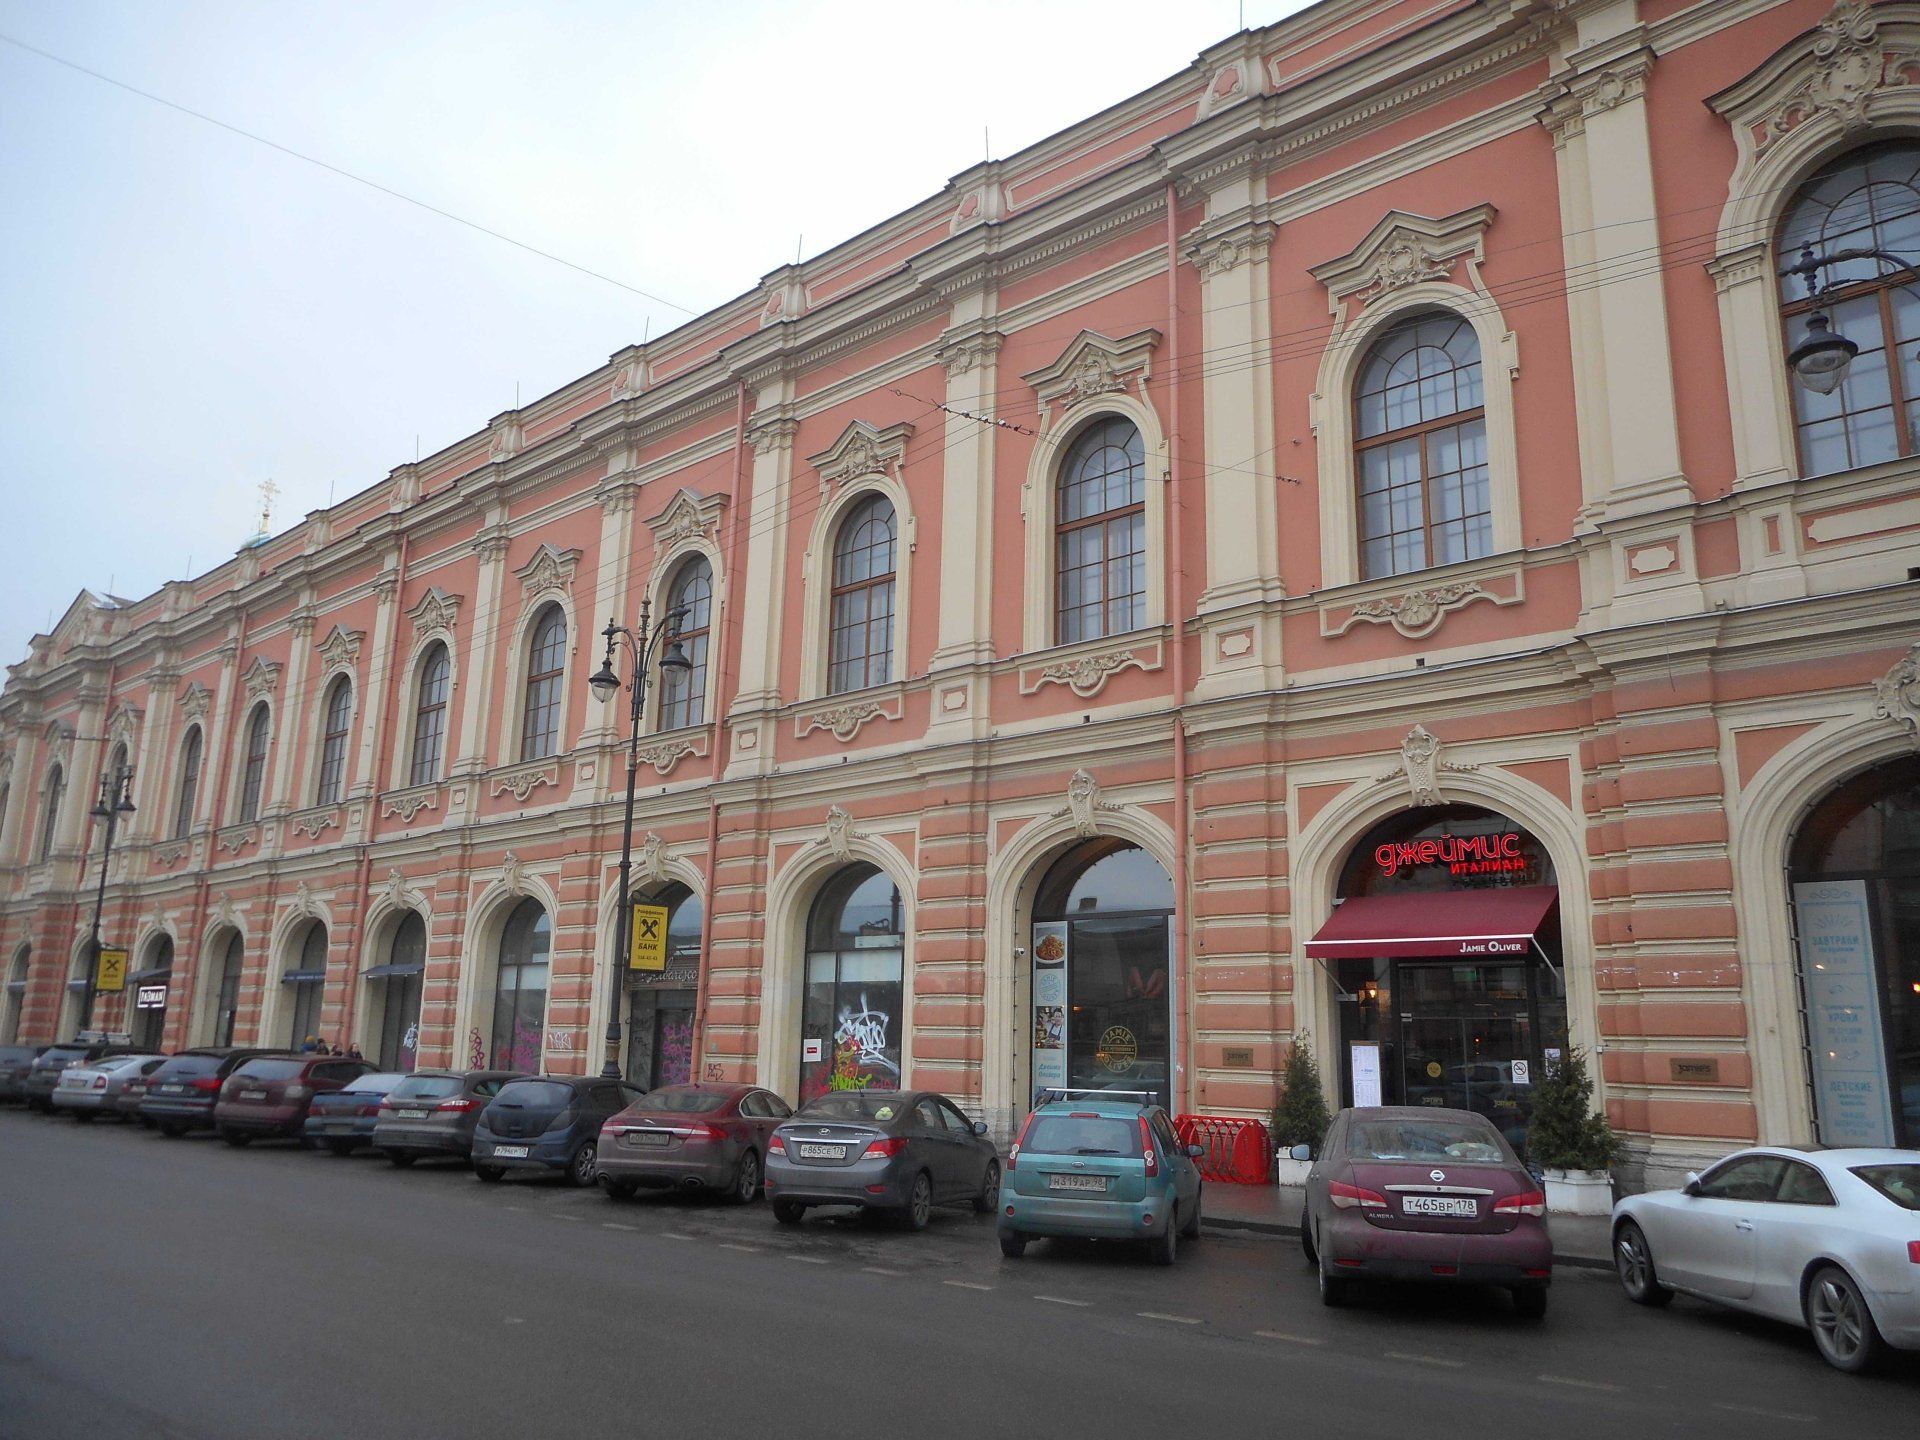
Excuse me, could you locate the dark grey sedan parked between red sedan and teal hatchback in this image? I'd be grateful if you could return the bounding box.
[766,1091,1000,1231]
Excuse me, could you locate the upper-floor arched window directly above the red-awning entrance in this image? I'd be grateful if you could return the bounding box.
[1354,315,1494,580]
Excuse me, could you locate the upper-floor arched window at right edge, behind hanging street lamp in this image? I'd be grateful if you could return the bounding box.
[1780,140,1920,476]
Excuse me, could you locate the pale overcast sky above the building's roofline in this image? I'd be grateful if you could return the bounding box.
[0,0,1300,662]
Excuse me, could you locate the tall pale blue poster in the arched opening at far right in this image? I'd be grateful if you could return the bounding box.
[1793,879,1893,1146]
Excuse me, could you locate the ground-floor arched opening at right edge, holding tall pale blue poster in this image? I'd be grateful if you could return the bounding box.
[1789,758,1920,1146]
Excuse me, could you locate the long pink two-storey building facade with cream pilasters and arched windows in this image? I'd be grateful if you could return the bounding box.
[0,0,1920,1181]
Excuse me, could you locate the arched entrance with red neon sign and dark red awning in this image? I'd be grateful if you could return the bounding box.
[1308,804,1567,1152]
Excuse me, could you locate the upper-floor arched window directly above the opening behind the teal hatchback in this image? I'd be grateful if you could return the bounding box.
[1054,415,1146,645]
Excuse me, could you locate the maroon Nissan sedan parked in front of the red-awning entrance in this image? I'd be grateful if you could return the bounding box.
[1294,1106,1553,1319]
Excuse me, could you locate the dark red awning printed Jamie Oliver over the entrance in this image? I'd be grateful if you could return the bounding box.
[1308,885,1559,960]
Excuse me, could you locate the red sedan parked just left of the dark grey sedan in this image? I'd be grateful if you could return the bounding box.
[599,1085,793,1204]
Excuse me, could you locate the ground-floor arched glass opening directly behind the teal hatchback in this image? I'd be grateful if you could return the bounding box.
[1029,837,1173,1108]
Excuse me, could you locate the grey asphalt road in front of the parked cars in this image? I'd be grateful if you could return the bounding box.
[0,1110,1920,1440]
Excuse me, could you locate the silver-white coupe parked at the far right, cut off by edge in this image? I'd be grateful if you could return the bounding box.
[1613,1148,1920,1373]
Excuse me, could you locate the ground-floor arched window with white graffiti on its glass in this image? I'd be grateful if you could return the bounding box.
[801,864,906,1100]
